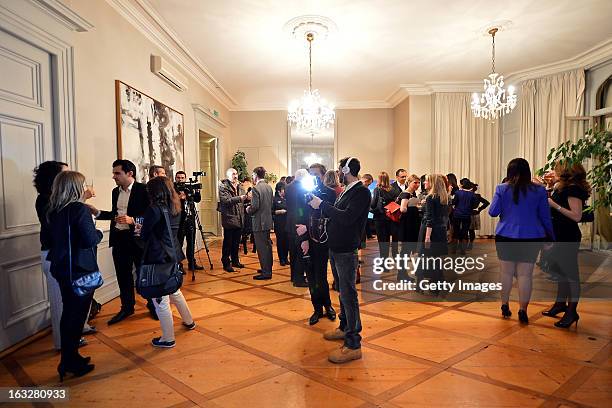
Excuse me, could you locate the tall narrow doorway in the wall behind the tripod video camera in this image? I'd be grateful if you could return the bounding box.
[198,130,219,235]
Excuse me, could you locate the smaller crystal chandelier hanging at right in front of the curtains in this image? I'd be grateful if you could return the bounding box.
[472,28,517,120]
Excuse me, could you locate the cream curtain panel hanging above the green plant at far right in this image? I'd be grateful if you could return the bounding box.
[519,69,585,172]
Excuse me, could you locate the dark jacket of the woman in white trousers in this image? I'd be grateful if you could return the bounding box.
[140,205,185,264]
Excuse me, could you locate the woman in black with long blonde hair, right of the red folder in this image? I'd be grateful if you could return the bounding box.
[417,174,449,295]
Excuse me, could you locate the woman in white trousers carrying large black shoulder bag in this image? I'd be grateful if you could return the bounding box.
[140,177,196,348]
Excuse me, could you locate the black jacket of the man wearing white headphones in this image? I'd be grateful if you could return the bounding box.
[320,182,370,252]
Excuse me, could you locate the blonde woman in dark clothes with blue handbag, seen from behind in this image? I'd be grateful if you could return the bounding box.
[47,171,102,381]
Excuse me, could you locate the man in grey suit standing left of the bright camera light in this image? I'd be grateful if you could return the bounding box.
[246,167,274,280]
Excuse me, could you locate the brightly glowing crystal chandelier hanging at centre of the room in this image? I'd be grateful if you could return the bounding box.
[287,32,336,133]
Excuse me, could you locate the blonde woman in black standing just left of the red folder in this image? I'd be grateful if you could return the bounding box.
[370,171,399,258]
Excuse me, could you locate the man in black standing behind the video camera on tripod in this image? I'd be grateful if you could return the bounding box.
[174,170,204,271]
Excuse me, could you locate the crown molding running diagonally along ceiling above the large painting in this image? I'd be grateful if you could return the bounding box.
[106,0,236,109]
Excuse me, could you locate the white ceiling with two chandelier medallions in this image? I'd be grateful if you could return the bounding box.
[145,0,612,109]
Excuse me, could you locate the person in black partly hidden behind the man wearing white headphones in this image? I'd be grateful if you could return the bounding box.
[298,163,336,325]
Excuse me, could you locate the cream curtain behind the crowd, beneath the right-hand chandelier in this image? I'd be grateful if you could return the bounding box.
[433,93,501,235]
